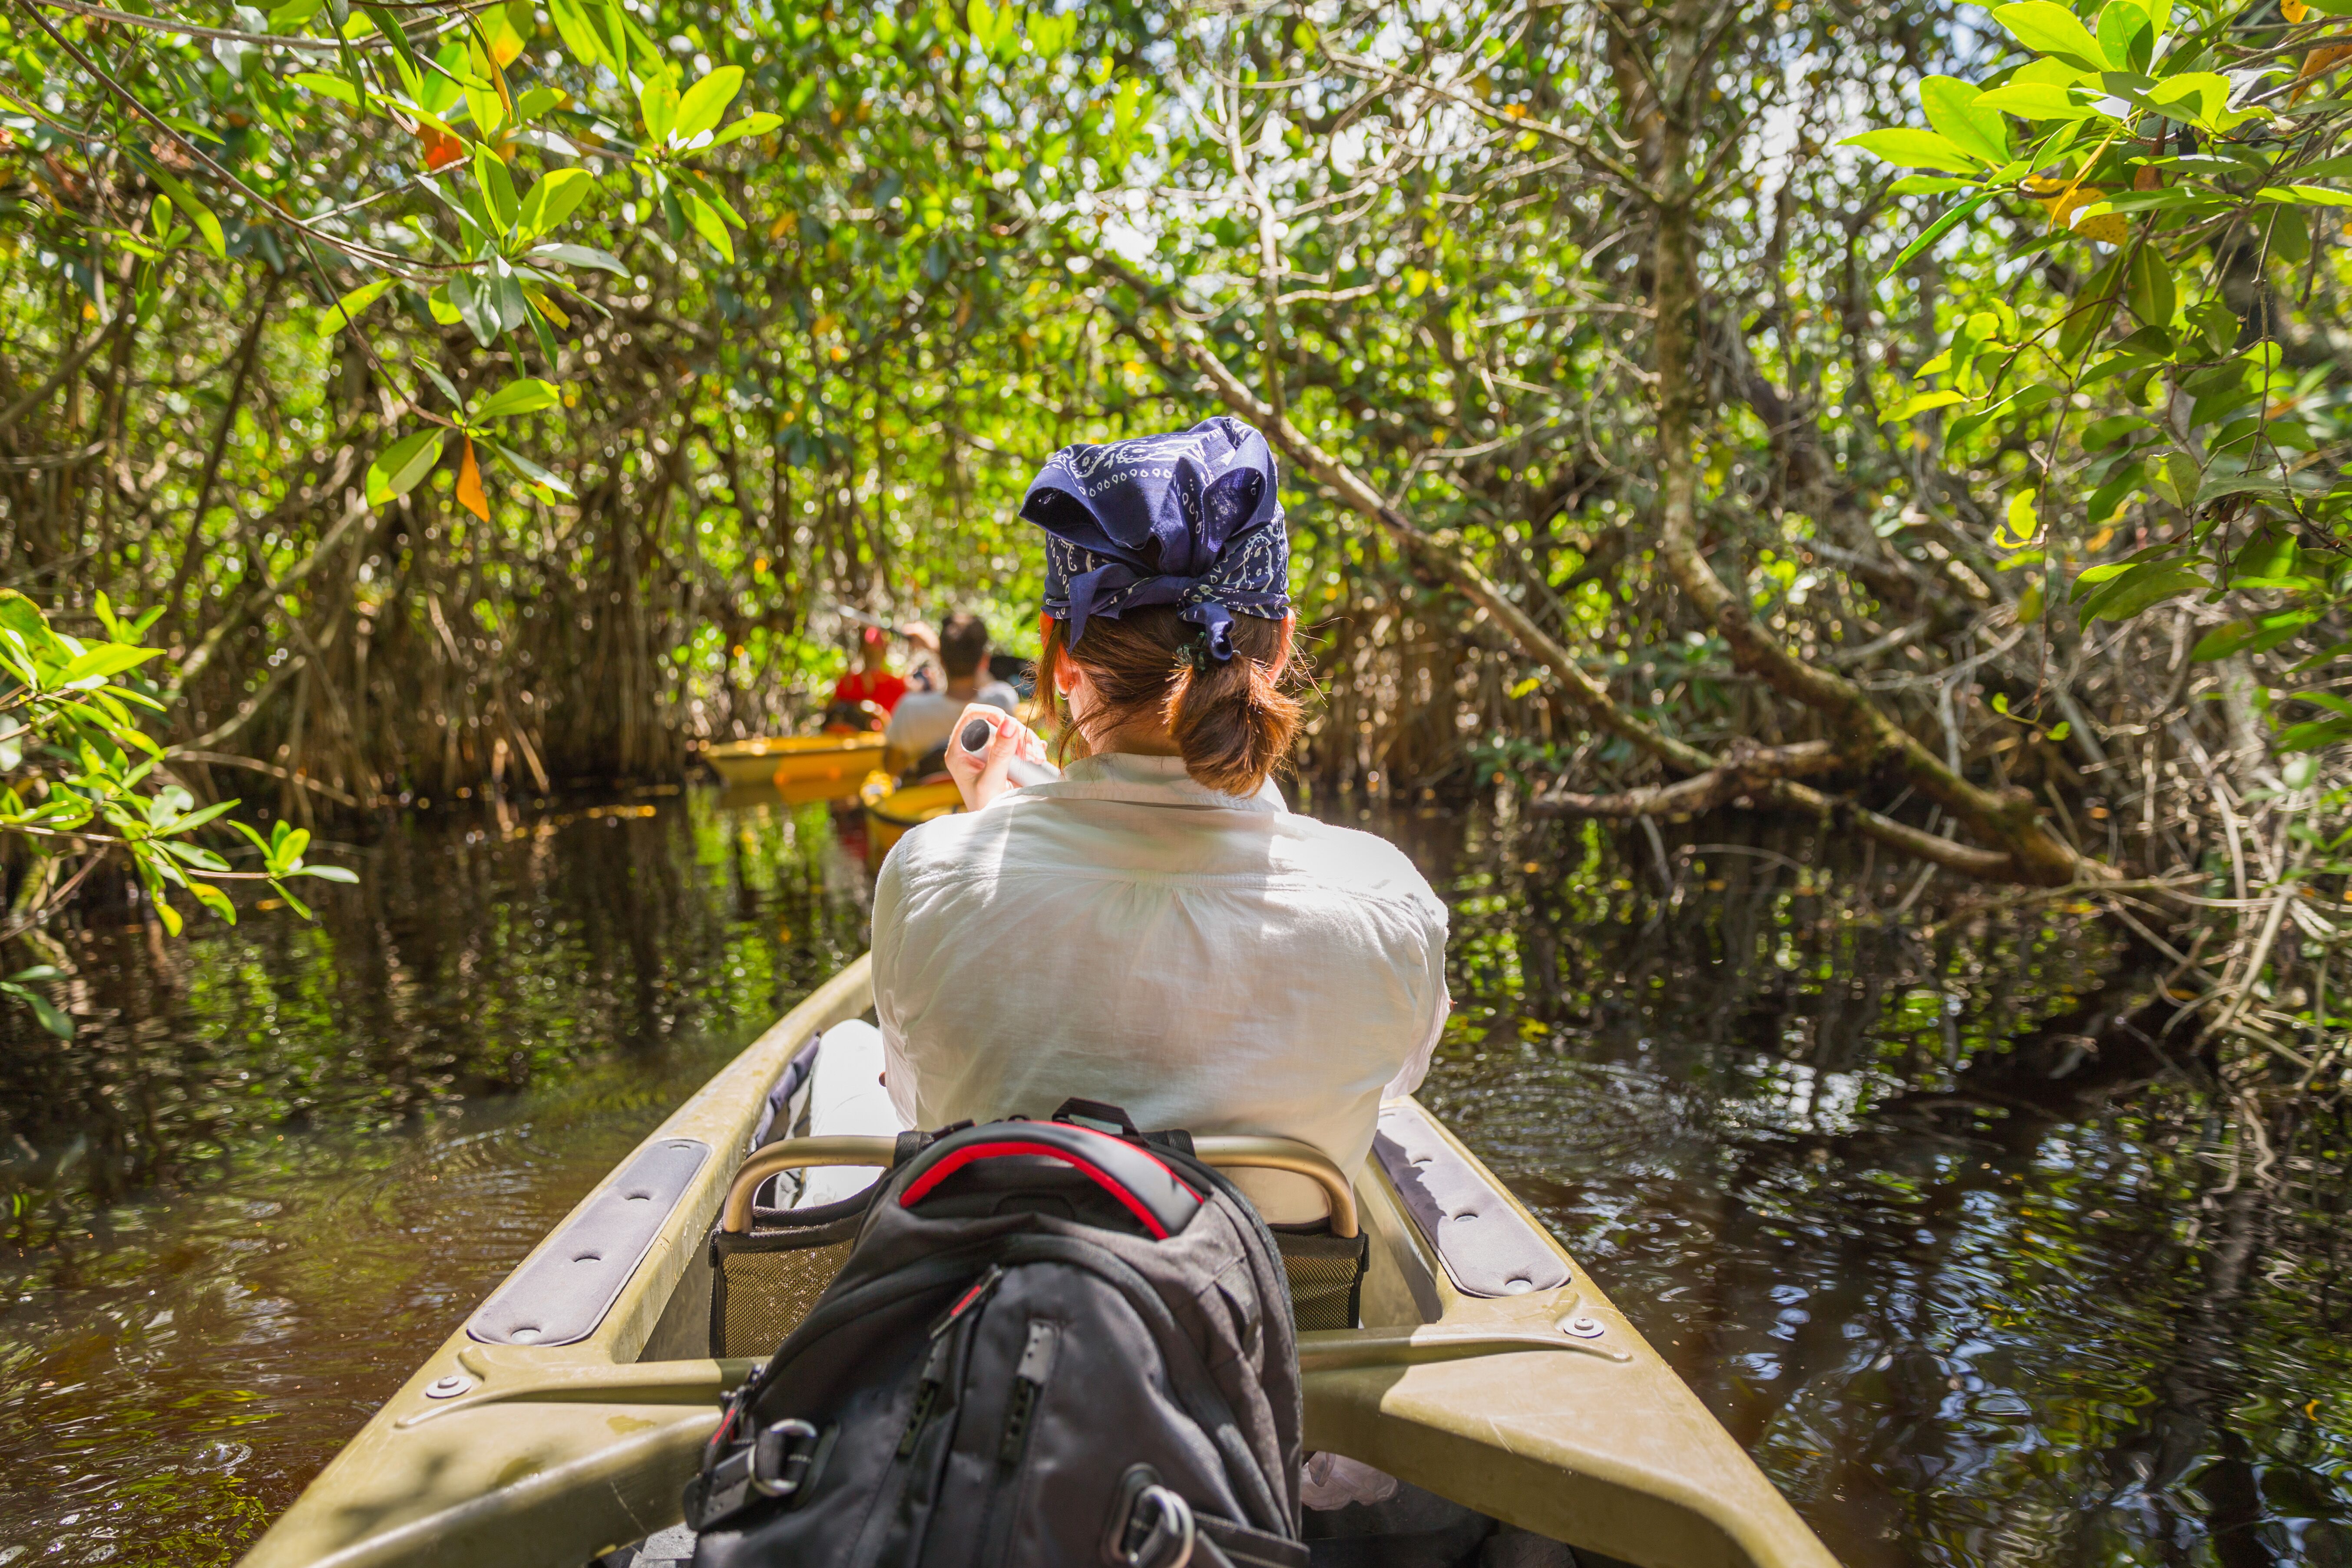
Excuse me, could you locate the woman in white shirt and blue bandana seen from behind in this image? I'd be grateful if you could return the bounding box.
[821,418,1446,1222]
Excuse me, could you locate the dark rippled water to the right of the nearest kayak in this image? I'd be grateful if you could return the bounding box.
[1399,818,2352,1568]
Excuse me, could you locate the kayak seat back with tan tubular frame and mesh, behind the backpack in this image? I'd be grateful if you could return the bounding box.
[710,1138,1371,1356]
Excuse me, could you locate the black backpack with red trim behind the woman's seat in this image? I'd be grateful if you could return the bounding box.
[687,1100,1308,1568]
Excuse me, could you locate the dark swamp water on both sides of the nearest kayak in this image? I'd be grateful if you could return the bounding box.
[0,792,2352,1568]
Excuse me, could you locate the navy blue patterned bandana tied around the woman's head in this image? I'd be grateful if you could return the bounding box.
[1021,414,1291,661]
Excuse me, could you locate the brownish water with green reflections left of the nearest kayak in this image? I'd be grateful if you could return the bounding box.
[0,797,863,1566]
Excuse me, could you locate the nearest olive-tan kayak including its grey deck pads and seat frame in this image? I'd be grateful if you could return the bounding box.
[245,957,1835,1568]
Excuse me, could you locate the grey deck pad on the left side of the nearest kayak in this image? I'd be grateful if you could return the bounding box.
[466,1138,710,1345]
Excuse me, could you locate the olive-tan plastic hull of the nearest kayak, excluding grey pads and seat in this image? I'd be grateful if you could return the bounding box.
[245,957,1835,1568]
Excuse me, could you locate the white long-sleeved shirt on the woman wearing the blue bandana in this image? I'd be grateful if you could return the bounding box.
[873,754,1449,1220]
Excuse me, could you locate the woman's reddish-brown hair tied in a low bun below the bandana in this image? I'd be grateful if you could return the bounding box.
[1037,604,1305,794]
